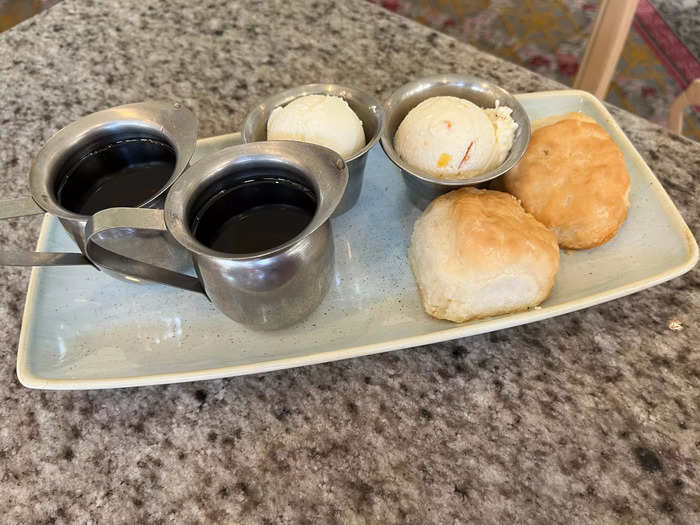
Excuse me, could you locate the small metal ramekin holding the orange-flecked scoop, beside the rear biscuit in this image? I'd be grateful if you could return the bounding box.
[381,75,530,209]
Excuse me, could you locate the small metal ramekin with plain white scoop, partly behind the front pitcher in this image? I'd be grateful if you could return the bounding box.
[241,84,384,217]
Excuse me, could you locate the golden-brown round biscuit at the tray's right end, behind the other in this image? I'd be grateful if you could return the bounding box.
[502,113,630,249]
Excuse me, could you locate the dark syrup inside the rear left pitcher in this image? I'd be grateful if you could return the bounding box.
[56,138,176,215]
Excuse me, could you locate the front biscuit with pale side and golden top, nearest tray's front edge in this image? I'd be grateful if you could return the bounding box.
[408,188,559,322]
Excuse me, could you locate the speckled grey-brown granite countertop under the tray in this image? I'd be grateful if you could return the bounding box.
[0,0,700,524]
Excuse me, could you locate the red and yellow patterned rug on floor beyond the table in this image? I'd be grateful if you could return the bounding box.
[370,0,700,141]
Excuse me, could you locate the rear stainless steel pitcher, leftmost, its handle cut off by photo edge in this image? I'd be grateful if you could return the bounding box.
[0,101,197,280]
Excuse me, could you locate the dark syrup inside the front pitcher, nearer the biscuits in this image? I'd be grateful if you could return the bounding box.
[191,175,316,254]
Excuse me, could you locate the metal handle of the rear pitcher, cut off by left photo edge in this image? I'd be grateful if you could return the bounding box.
[0,197,92,266]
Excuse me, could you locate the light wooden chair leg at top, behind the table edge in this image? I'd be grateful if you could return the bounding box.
[574,0,638,100]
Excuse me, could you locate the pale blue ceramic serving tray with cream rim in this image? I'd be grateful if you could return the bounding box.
[17,91,698,389]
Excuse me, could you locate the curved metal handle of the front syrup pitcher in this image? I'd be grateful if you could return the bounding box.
[85,208,204,294]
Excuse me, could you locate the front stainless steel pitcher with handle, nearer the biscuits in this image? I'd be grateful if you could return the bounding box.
[85,141,348,329]
